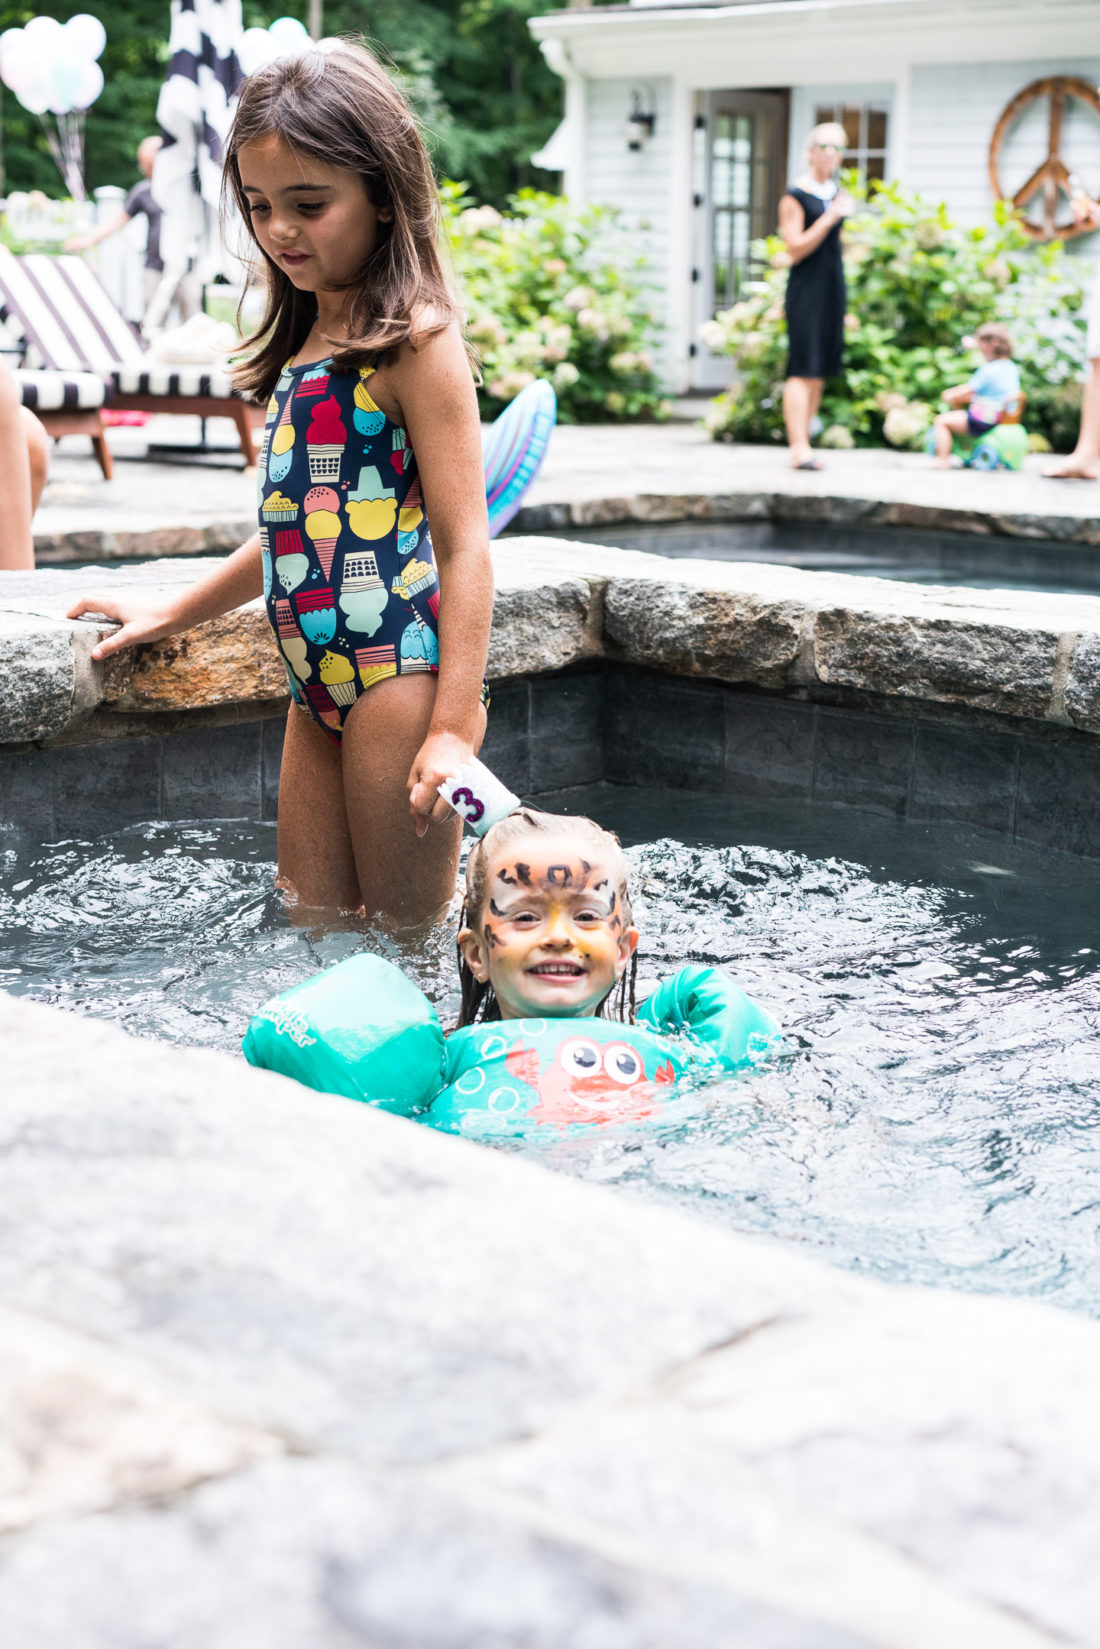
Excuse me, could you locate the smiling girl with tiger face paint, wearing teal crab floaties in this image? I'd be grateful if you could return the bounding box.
[244,808,778,1138]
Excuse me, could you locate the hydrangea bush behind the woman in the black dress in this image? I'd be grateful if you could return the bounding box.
[703,176,1085,452]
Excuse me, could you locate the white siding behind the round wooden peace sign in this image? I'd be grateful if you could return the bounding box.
[897,56,1100,267]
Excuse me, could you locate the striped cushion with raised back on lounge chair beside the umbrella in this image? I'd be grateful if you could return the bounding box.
[0,247,233,397]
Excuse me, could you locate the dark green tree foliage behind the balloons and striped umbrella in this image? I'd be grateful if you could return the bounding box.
[0,0,562,204]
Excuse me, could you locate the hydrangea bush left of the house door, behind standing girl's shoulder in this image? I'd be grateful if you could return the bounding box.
[442,183,666,424]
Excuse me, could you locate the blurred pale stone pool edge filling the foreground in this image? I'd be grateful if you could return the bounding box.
[0,996,1100,1649]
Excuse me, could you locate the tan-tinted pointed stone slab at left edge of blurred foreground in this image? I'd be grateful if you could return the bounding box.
[0,1306,284,1530]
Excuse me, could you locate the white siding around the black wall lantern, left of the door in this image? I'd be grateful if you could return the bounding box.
[584,79,676,364]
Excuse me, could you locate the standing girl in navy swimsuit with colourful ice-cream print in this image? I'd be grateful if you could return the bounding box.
[71,41,493,922]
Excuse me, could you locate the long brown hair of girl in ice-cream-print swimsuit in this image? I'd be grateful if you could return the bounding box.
[223,40,460,401]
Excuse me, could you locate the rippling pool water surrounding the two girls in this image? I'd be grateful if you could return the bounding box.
[0,785,1100,1316]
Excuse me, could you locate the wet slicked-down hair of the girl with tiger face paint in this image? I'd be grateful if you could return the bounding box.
[455,808,638,1029]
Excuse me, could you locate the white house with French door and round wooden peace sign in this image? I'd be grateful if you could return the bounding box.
[531,0,1100,389]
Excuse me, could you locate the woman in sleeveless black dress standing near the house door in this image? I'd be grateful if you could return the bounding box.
[778,120,853,470]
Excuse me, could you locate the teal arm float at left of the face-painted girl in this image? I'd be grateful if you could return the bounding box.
[244,955,444,1116]
